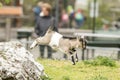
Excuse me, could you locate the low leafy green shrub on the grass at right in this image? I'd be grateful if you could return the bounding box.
[84,56,116,67]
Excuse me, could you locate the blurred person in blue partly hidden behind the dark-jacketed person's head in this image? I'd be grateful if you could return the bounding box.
[33,2,43,23]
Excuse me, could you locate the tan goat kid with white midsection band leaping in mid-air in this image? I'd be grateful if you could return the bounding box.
[30,28,86,65]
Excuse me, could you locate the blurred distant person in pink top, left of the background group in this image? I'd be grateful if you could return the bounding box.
[61,10,69,28]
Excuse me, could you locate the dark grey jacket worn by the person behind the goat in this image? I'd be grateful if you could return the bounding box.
[35,16,58,36]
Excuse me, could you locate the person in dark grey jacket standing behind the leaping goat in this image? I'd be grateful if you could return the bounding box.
[35,3,58,58]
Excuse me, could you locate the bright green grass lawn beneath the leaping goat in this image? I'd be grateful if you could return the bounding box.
[38,59,120,80]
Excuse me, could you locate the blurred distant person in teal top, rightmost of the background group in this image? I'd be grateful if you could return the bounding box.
[74,9,84,28]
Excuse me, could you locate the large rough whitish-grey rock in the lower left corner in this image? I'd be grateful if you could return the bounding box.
[0,41,46,80]
